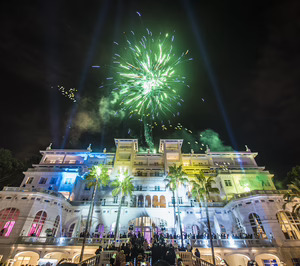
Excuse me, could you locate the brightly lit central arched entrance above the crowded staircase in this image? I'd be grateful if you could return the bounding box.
[128,216,167,243]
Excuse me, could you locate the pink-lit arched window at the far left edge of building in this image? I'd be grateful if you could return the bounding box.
[0,208,20,237]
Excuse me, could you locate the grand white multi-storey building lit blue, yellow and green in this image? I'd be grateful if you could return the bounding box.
[0,139,300,266]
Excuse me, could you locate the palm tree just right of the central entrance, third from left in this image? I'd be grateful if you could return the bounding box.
[165,164,189,247]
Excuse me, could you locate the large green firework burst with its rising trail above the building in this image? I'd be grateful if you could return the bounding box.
[107,19,192,148]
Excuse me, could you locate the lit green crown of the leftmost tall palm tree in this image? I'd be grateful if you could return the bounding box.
[85,165,110,187]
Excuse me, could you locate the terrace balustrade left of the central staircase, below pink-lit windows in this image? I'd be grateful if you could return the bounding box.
[16,236,128,247]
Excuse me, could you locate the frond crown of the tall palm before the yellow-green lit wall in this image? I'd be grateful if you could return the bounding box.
[191,172,220,202]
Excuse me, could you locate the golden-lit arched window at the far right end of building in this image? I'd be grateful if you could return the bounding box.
[276,211,300,239]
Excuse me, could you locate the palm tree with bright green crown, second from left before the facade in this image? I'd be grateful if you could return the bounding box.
[111,172,134,240]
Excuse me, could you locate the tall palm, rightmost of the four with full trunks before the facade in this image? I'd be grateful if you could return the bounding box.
[191,172,220,265]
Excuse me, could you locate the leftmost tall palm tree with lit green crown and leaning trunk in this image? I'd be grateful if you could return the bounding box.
[80,165,110,261]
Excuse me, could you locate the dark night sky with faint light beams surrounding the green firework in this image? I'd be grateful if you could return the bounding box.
[0,0,300,181]
